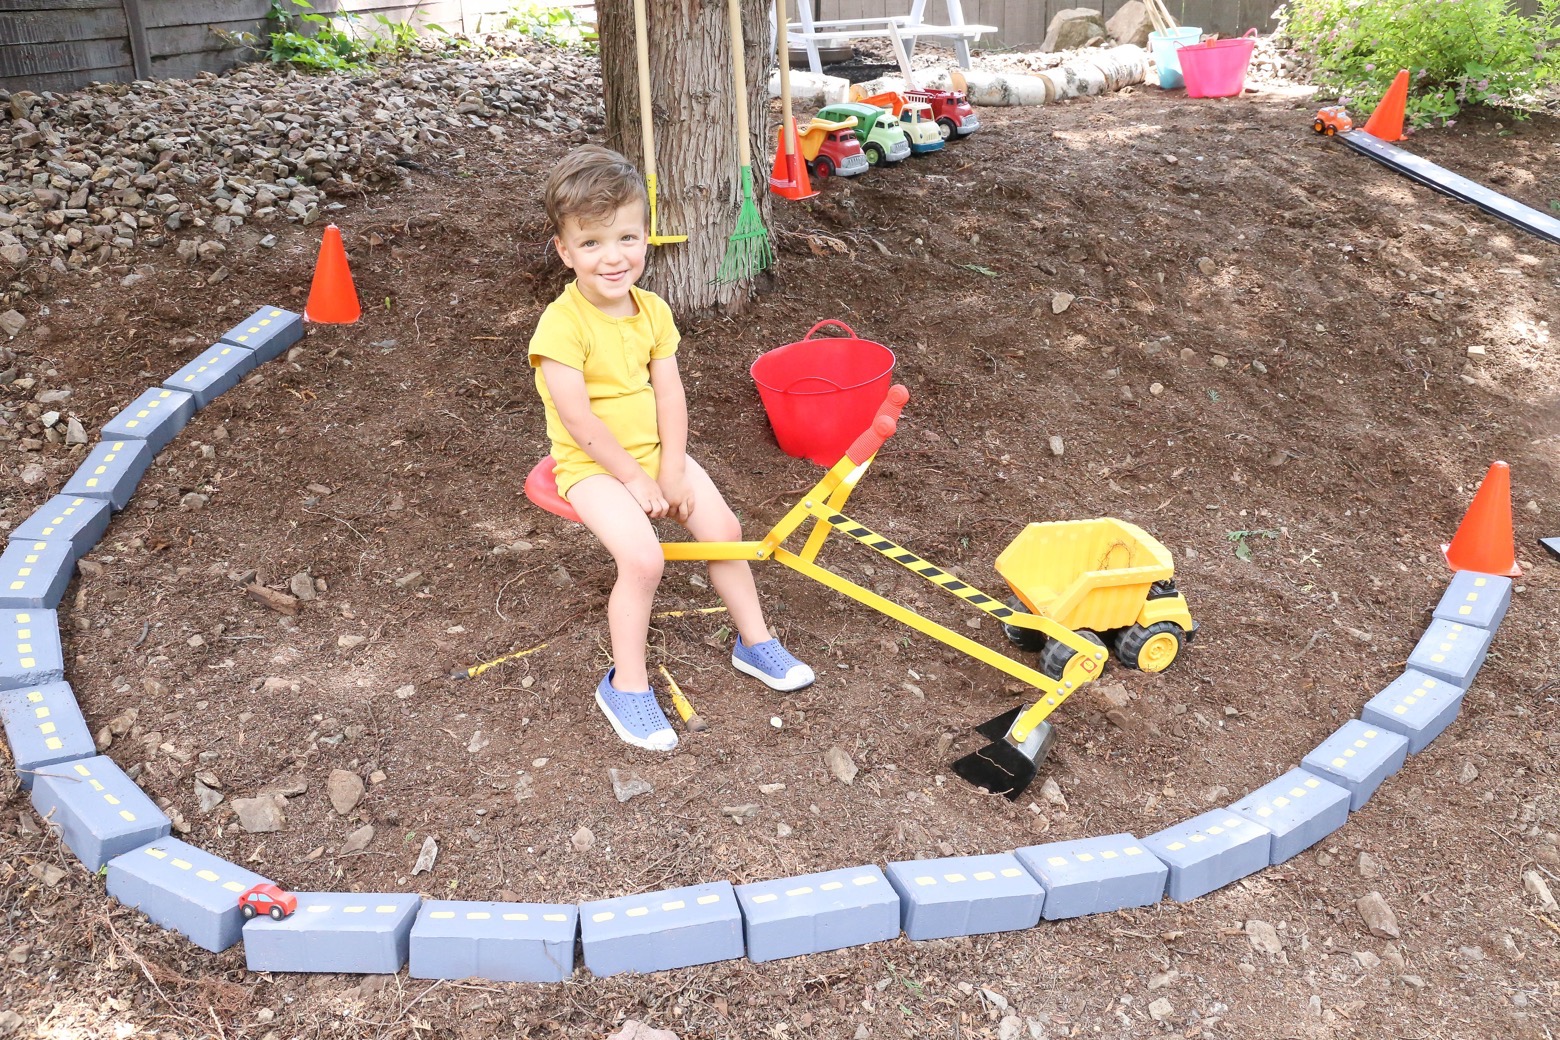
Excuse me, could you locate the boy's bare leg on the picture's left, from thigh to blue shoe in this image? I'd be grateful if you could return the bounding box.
[569,474,664,691]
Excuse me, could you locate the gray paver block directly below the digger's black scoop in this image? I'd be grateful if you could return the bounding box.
[888,853,1045,940]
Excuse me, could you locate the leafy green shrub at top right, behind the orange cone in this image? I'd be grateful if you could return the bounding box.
[1278,0,1560,126]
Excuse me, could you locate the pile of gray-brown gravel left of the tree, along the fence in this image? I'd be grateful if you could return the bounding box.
[0,37,602,313]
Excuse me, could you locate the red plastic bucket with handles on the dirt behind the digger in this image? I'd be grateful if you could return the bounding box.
[750,318,894,466]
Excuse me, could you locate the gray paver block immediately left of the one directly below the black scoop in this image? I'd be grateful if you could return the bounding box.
[736,864,899,962]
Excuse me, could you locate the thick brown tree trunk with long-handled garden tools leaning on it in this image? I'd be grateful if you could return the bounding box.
[596,0,774,315]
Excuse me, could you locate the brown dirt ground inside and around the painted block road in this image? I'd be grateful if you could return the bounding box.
[0,54,1560,1040]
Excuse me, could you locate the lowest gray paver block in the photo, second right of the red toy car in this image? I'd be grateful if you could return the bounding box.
[407,900,579,982]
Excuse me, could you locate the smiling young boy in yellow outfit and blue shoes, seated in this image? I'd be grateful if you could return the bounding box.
[530,145,813,752]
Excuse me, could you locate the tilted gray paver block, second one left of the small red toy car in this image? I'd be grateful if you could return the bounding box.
[33,755,168,870]
